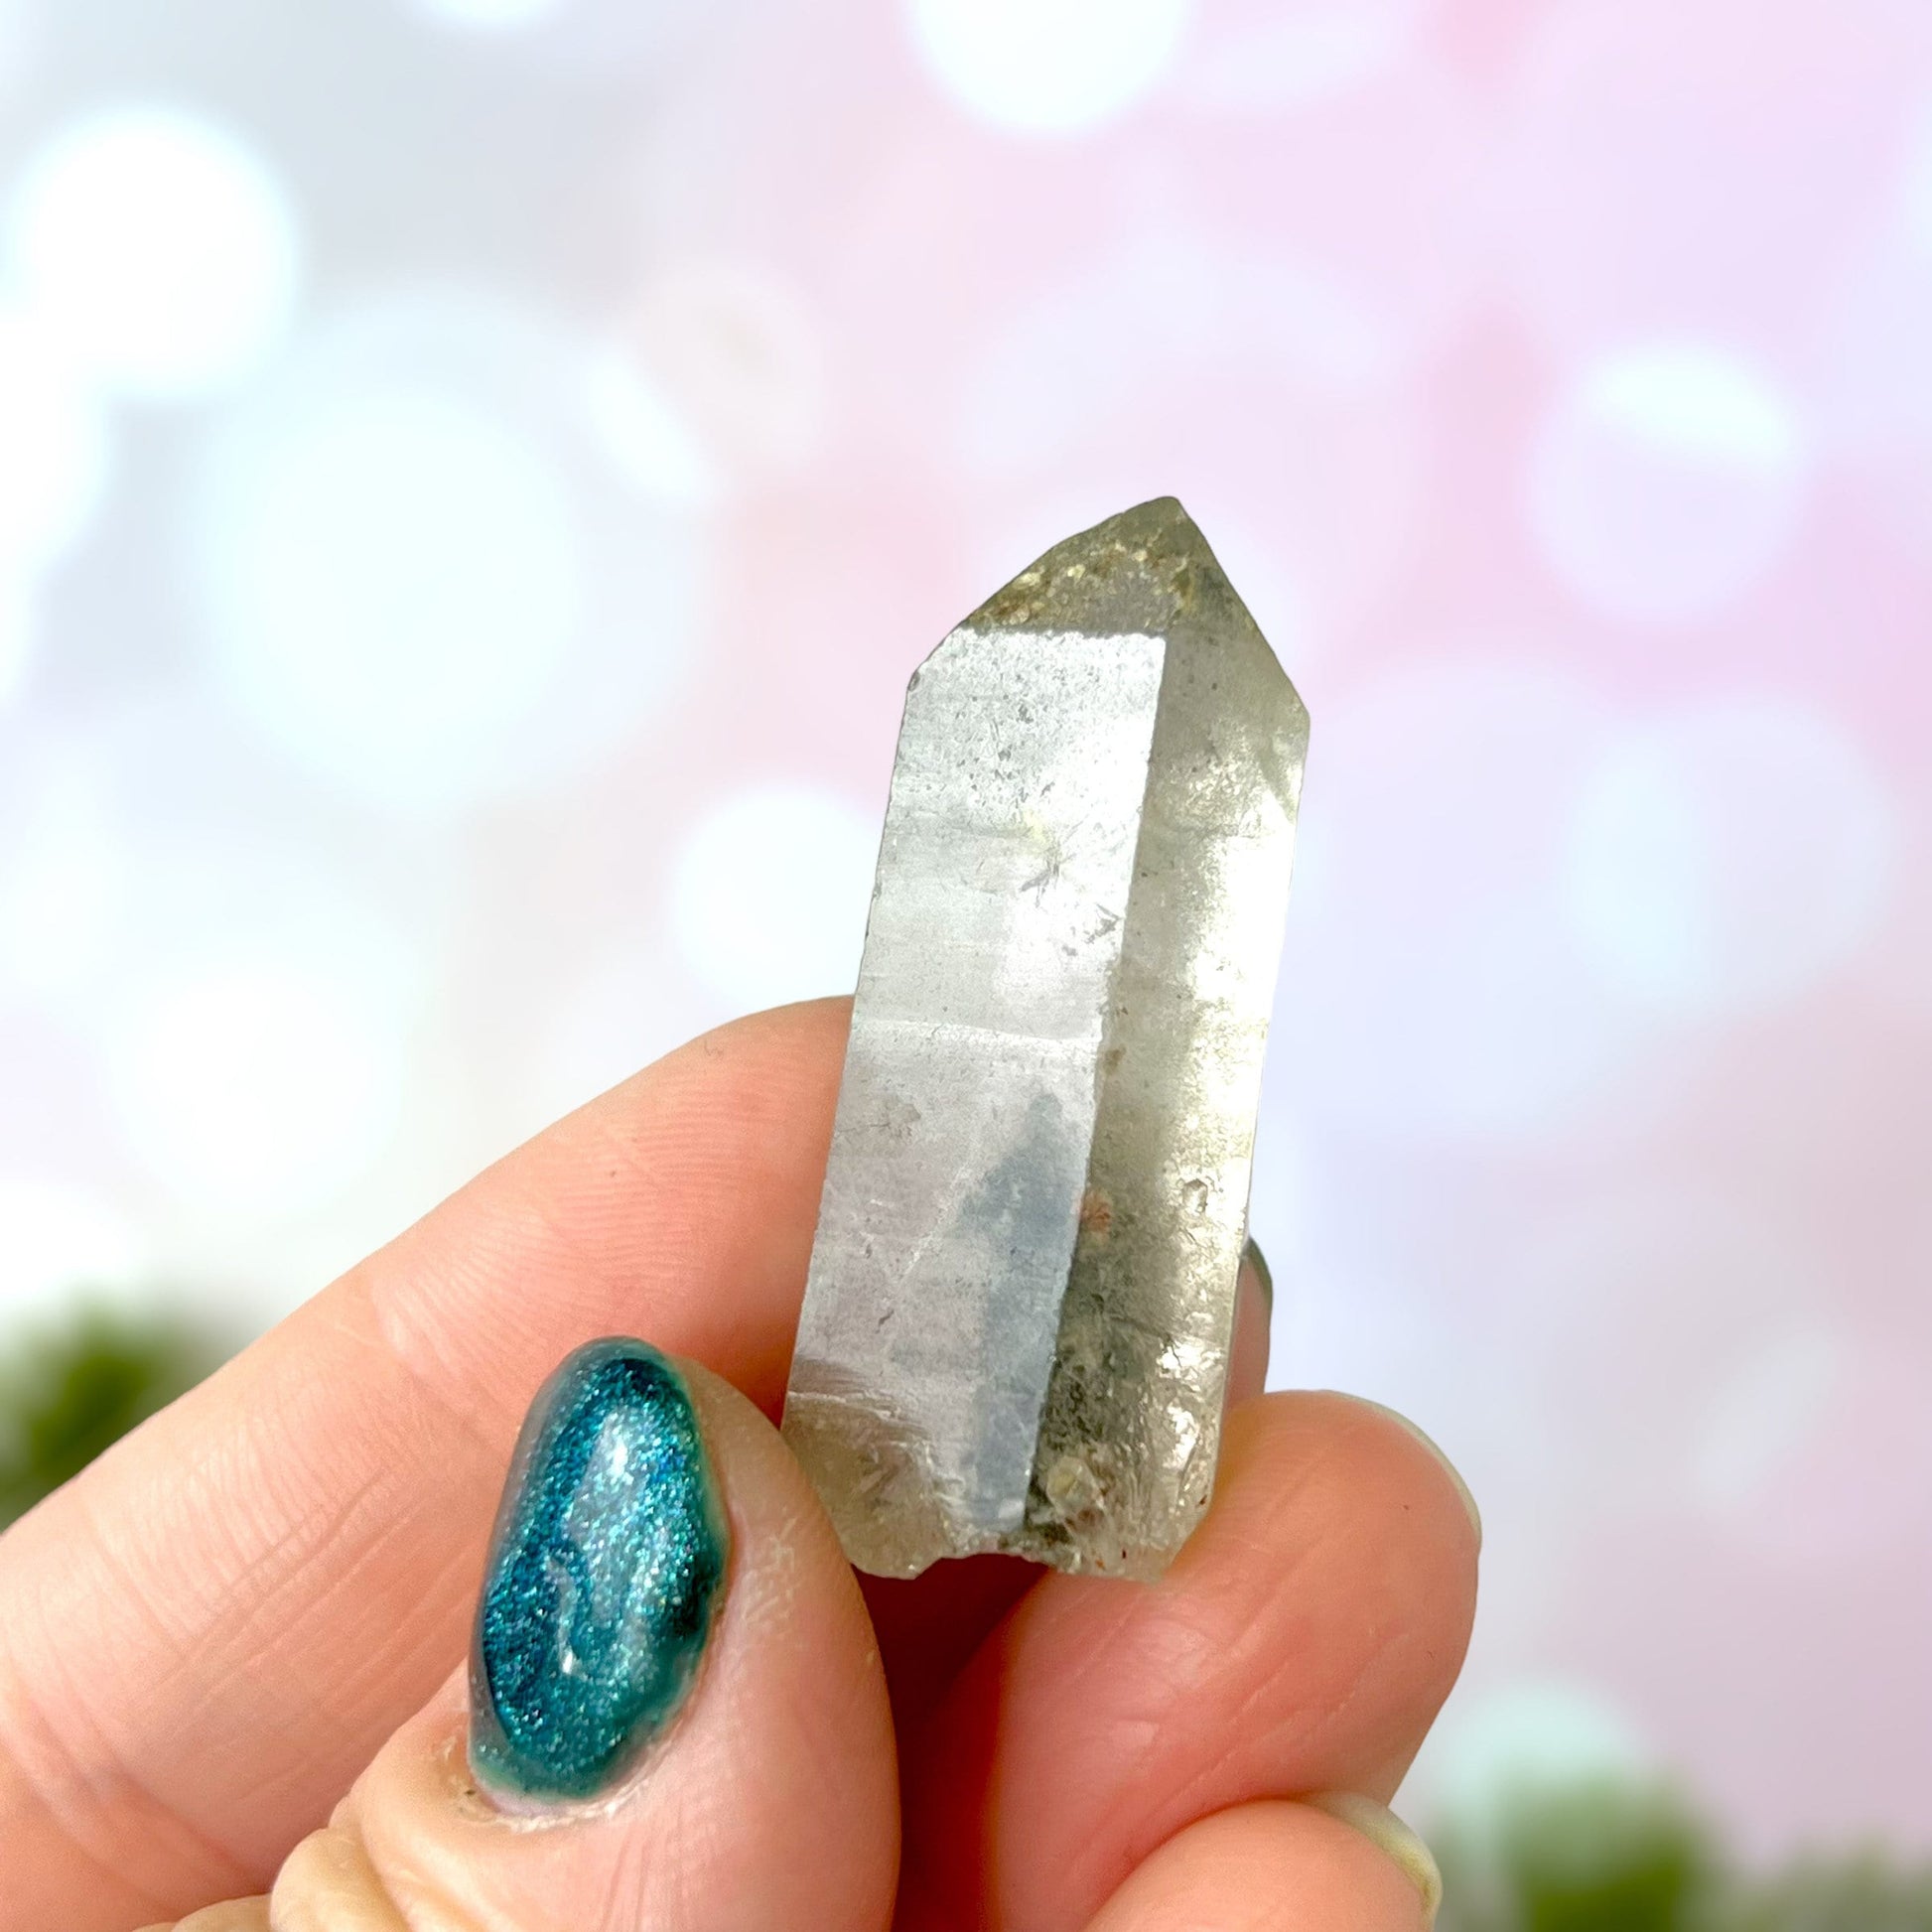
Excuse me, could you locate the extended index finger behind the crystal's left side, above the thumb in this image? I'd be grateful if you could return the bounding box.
[0,1001,848,1932]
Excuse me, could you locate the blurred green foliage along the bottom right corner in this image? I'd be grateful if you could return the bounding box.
[1436,1781,1932,1932]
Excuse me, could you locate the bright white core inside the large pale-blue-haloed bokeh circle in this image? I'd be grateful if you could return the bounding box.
[209,388,586,798]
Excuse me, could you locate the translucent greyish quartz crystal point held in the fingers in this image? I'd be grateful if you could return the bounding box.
[784,496,1308,1577]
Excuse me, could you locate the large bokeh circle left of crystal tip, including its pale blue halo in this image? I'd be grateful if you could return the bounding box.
[192,290,703,817]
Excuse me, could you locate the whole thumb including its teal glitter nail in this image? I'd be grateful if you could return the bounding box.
[262,1341,898,1932]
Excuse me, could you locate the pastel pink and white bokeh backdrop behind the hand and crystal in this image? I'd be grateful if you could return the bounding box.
[0,0,1932,1857]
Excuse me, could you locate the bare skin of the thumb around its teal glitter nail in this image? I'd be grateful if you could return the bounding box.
[321,1358,898,1932]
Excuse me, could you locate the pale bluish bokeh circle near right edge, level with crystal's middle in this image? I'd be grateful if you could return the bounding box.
[1565,696,1901,1019]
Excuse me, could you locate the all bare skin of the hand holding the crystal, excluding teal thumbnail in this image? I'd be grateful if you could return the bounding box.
[0,1001,1480,1932]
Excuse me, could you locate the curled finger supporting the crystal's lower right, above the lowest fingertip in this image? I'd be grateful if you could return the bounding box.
[902,1393,1478,1932]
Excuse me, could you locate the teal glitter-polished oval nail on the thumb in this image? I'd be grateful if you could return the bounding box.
[470,1337,729,1799]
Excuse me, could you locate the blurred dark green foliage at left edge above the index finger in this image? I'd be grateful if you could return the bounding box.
[0,1306,228,1526]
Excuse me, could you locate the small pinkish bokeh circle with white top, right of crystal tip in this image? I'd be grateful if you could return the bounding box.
[1528,344,1807,624]
